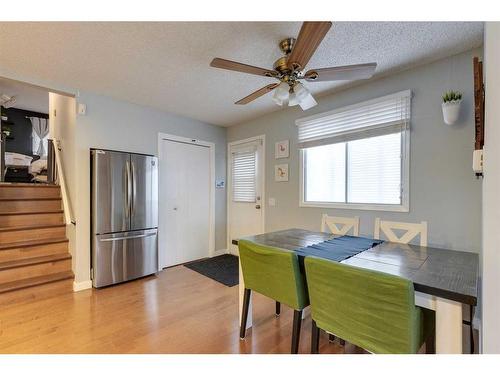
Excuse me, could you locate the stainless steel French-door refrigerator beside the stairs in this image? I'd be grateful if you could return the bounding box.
[91,149,159,288]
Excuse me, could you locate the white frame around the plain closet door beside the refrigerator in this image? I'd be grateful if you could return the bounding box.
[158,133,215,264]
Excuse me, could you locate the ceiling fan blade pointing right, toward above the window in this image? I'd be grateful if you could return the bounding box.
[304,63,377,82]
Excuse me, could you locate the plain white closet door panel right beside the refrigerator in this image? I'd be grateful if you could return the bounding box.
[158,139,211,268]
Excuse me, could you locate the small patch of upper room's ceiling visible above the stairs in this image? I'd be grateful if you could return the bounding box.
[0,77,49,113]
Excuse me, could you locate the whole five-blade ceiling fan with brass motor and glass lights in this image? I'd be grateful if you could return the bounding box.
[210,22,377,111]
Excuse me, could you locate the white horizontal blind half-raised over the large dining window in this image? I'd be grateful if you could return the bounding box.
[296,90,411,148]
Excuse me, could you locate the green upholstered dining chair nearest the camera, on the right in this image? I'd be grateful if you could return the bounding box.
[305,257,435,353]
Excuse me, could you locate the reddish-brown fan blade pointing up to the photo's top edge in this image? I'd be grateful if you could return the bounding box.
[288,22,332,69]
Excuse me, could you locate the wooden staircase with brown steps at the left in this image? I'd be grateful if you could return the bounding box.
[0,184,73,306]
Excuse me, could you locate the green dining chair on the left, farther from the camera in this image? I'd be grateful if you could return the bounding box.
[238,240,309,354]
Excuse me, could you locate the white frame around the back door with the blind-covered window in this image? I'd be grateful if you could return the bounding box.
[226,134,266,254]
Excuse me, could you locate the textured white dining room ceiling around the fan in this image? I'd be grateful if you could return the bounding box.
[0,22,483,126]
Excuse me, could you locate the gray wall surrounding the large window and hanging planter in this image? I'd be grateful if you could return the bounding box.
[227,49,482,252]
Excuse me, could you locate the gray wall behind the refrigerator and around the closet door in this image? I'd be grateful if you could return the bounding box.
[71,93,226,282]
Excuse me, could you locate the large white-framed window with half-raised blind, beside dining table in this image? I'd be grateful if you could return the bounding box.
[297,91,411,211]
